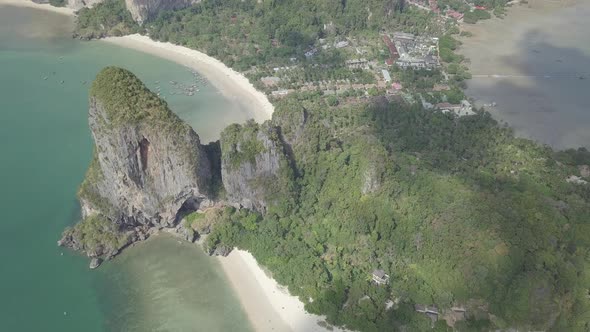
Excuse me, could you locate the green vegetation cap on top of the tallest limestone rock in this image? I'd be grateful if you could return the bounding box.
[90,67,190,131]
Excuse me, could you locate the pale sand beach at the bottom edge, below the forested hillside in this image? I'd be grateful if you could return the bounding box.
[217,249,346,332]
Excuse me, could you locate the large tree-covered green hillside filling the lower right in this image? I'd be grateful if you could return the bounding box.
[209,96,590,331]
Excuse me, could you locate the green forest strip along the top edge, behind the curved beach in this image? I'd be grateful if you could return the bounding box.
[76,0,438,70]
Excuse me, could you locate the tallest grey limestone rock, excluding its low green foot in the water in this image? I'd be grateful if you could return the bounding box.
[81,68,211,227]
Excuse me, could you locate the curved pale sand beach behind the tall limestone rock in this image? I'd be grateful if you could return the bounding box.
[102,34,274,122]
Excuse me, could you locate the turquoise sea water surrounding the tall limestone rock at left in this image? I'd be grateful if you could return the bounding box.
[0,7,251,331]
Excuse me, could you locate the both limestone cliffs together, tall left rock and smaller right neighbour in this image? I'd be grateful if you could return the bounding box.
[59,67,296,258]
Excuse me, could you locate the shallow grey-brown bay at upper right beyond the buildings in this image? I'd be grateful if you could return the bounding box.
[461,0,590,149]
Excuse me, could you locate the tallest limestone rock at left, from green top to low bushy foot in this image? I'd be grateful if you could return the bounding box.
[62,67,211,256]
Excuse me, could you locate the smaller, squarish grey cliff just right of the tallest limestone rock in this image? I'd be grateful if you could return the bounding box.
[220,121,293,213]
